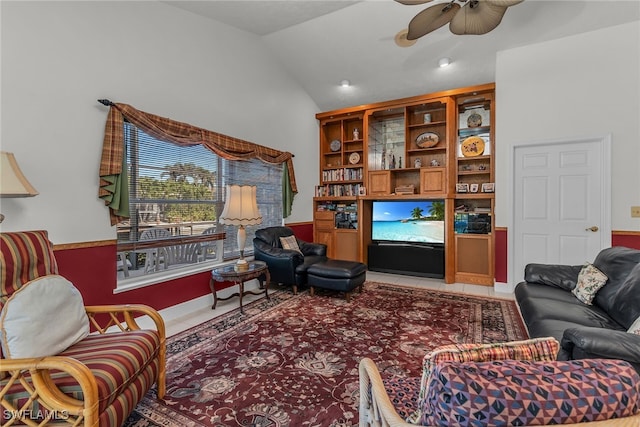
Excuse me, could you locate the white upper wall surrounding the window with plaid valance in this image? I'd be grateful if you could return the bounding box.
[0,1,318,244]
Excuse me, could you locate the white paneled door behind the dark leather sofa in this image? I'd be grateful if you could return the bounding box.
[509,137,611,285]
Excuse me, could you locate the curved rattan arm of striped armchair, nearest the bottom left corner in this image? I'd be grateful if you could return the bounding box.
[0,356,98,427]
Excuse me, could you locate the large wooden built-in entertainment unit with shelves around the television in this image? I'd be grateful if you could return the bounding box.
[313,84,495,285]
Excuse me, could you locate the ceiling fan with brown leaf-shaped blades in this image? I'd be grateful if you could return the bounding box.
[395,0,524,44]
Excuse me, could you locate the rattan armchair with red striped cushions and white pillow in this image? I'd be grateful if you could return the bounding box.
[0,231,165,427]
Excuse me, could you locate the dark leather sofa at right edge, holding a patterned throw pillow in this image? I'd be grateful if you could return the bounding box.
[515,247,640,372]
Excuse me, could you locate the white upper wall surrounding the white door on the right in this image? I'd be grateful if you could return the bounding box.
[496,21,640,231]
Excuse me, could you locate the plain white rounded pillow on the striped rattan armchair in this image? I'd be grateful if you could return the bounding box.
[0,275,89,359]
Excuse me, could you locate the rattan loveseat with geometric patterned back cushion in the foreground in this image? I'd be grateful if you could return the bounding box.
[360,338,640,427]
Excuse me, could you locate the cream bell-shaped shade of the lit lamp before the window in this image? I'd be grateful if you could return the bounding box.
[219,185,262,226]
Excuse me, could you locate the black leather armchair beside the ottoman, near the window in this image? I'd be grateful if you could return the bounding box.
[253,227,327,294]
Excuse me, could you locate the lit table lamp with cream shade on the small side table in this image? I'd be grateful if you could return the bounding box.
[218,185,262,271]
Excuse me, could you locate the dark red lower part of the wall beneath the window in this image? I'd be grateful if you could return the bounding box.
[54,223,313,310]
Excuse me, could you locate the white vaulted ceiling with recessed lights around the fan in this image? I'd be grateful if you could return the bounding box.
[165,0,640,111]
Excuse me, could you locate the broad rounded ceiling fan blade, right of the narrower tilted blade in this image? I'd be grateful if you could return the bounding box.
[449,0,507,35]
